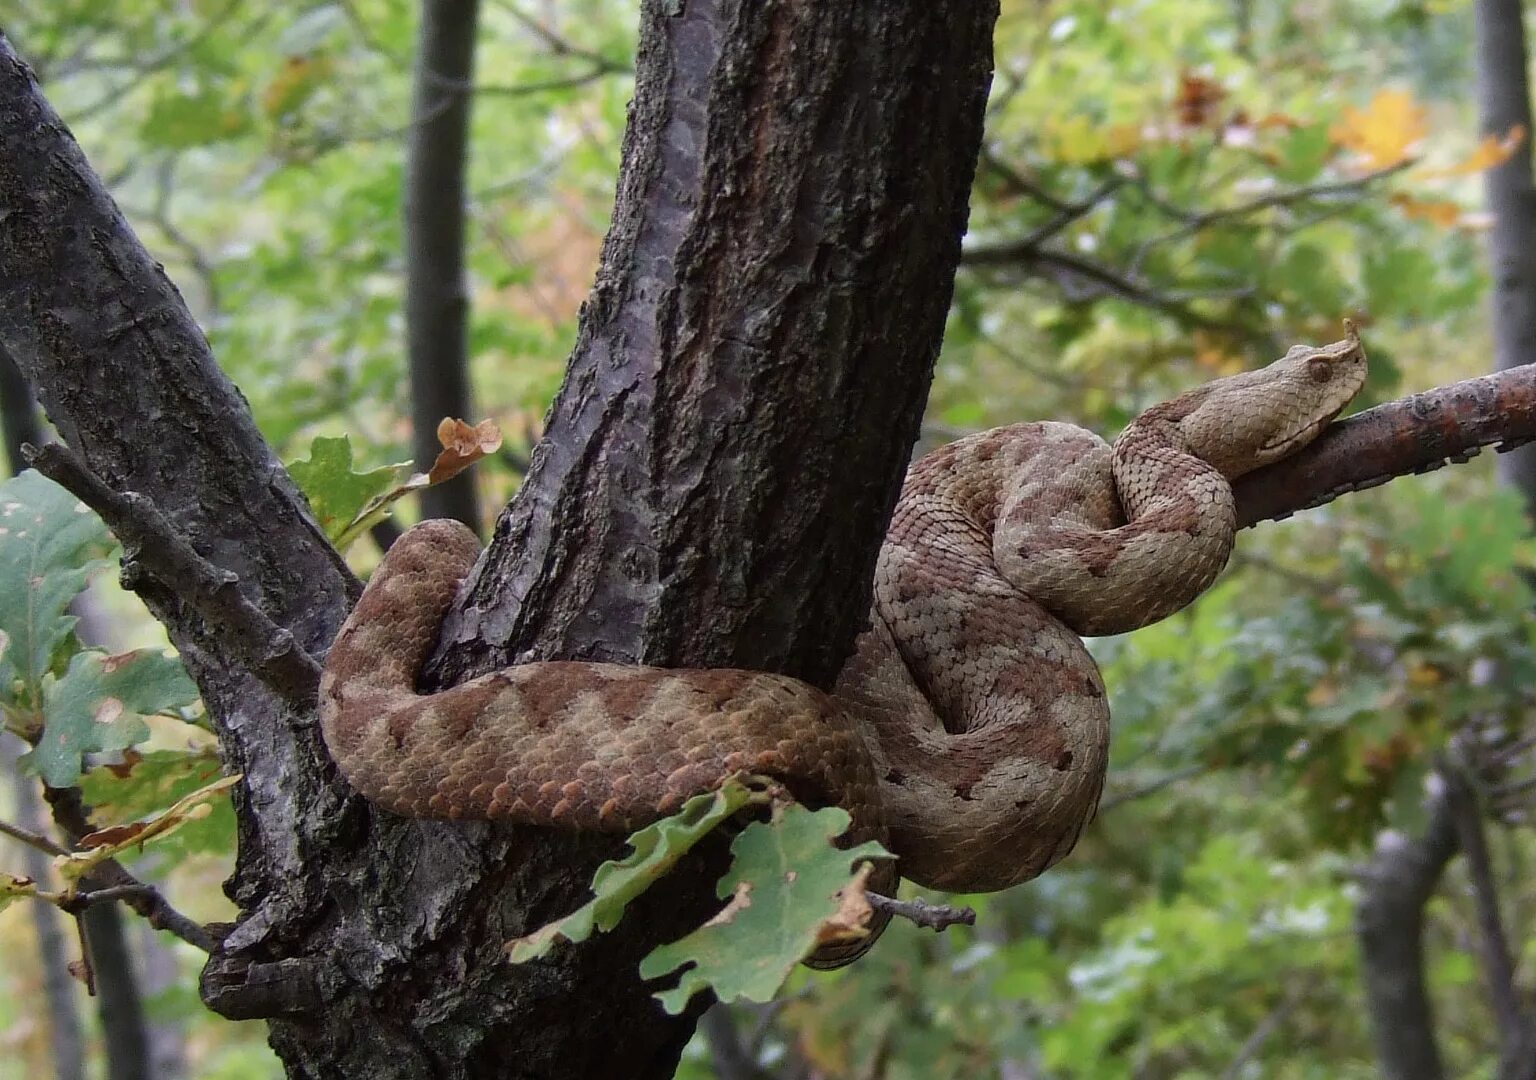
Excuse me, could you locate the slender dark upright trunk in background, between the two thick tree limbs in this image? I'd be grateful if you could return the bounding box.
[404,0,479,530]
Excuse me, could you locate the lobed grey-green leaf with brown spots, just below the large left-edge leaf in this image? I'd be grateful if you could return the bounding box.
[22,648,198,788]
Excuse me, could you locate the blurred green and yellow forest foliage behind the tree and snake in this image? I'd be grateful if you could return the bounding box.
[0,0,1536,1080]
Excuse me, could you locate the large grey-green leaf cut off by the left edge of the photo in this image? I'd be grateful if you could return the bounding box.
[0,469,112,708]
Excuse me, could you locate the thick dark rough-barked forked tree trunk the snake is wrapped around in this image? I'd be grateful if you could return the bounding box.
[0,0,997,1077]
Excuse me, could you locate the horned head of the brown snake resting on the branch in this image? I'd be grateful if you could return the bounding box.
[1164,321,1366,479]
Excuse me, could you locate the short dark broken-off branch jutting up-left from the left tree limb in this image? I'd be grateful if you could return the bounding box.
[23,442,319,711]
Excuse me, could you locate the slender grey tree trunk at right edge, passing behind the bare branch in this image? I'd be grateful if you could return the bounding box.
[1475,0,1536,513]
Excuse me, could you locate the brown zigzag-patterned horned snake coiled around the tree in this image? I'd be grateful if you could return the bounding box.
[319,329,1366,965]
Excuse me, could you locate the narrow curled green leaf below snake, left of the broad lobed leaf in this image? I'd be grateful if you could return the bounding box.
[507,777,766,963]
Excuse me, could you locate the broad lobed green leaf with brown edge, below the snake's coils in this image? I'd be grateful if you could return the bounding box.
[641,805,889,1014]
